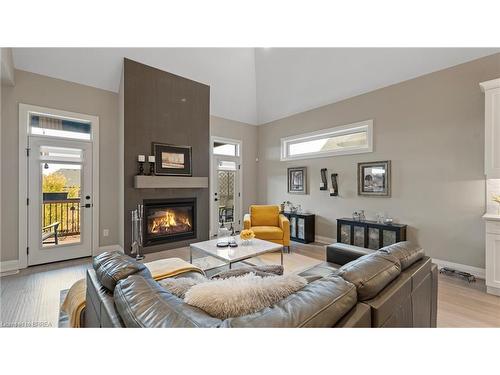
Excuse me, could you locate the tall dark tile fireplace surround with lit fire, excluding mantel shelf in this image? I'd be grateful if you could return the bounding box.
[121,59,210,254]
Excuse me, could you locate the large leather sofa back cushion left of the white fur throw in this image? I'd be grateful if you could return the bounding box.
[114,274,221,328]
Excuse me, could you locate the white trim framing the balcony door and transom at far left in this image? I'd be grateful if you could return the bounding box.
[18,103,99,269]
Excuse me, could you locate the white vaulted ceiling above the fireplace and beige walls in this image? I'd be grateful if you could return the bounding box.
[13,48,500,124]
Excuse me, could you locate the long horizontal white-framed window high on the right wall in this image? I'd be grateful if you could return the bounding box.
[281,120,373,160]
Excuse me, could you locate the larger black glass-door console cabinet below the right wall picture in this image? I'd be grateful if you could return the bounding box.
[337,218,406,250]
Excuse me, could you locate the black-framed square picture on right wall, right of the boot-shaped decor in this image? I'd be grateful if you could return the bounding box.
[358,160,391,197]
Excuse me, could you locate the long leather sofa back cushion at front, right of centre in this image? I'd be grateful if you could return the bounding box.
[222,276,357,328]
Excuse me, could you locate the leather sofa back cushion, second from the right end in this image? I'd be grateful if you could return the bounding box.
[338,252,401,301]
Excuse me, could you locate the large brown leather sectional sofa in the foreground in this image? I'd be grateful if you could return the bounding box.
[83,242,437,327]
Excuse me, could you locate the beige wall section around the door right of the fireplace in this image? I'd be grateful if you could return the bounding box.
[210,116,258,214]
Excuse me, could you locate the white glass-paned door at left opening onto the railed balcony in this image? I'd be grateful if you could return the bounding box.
[28,136,93,265]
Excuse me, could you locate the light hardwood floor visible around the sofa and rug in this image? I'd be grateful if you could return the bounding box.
[0,243,500,327]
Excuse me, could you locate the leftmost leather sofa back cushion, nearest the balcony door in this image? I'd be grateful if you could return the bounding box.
[92,251,151,292]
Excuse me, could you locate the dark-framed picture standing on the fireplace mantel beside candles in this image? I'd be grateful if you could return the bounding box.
[152,142,193,177]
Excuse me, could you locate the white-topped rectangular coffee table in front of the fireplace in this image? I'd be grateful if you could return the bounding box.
[189,237,283,269]
